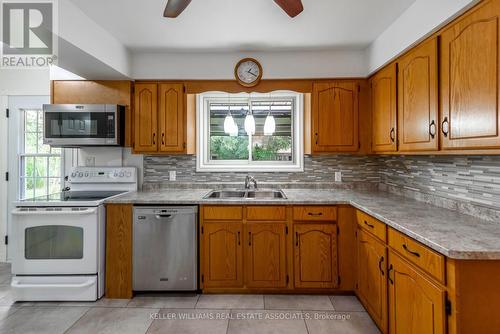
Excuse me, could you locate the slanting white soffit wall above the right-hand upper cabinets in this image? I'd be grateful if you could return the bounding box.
[366,0,478,74]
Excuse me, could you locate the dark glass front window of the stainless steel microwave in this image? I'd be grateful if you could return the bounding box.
[45,112,115,138]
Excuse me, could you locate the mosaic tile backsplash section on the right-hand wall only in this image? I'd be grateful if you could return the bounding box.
[378,156,500,210]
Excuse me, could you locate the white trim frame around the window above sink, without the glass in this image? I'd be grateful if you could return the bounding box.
[196,91,304,172]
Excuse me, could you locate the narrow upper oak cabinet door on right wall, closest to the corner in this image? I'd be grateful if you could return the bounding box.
[370,64,397,152]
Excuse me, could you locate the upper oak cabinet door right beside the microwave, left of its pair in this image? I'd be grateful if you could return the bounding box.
[134,84,158,152]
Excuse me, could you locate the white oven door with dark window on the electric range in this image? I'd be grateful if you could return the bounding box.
[12,207,100,275]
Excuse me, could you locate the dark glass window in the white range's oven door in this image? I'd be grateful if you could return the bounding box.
[24,225,83,260]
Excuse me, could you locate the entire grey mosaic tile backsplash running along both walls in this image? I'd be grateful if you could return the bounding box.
[144,155,500,214]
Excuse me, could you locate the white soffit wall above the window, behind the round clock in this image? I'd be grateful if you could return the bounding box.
[132,50,367,79]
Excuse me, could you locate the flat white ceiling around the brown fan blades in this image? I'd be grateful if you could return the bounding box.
[70,0,415,53]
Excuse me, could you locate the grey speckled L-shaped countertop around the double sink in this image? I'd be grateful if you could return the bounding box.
[107,189,500,260]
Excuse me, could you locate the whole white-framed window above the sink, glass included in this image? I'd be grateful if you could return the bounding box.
[197,91,303,172]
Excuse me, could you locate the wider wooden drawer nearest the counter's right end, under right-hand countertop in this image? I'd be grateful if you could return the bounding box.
[389,228,445,284]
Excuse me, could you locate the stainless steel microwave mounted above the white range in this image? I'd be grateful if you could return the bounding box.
[43,104,125,147]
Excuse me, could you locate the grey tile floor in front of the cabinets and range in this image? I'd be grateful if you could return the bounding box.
[0,264,379,334]
